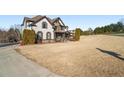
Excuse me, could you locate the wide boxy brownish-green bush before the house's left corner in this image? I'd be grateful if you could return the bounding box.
[22,29,35,45]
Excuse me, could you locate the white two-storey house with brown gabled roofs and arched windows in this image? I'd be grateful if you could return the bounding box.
[22,15,68,41]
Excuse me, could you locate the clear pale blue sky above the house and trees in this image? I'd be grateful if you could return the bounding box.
[0,15,124,30]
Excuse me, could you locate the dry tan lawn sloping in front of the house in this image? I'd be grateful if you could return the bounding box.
[17,35,124,76]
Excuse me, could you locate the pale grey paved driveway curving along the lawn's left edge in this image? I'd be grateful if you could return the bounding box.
[0,45,59,77]
